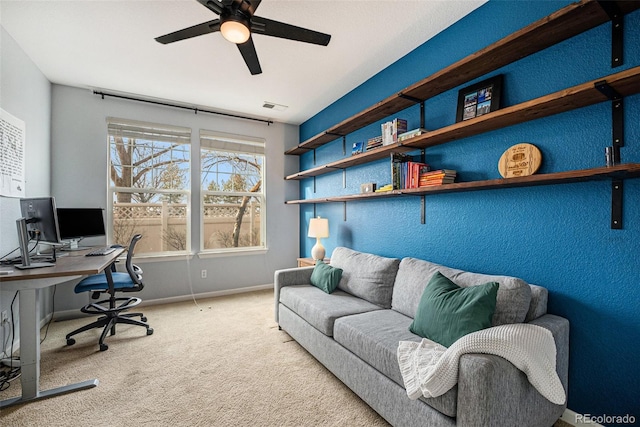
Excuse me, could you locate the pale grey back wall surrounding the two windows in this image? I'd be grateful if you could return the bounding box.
[51,85,299,310]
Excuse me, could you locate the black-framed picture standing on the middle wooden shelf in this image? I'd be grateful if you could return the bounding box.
[456,74,502,122]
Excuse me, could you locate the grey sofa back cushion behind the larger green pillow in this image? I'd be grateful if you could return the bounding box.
[392,258,531,326]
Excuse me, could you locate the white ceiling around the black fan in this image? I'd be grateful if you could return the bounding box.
[0,0,486,124]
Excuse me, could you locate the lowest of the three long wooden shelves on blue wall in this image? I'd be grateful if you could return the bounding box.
[285,163,640,205]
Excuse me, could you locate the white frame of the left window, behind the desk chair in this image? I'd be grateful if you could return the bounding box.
[107,117,193,258]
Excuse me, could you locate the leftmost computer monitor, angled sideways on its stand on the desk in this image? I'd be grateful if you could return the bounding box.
[16,197,62,269]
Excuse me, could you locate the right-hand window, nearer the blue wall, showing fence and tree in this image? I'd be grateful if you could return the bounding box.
[200,130,266,252]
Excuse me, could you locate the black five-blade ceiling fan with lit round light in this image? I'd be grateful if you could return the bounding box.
[156,0,331,75]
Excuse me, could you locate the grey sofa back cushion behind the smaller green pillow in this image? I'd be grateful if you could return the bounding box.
[331,247,400,308]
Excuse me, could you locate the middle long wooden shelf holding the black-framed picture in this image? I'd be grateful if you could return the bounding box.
[285,65,640,180]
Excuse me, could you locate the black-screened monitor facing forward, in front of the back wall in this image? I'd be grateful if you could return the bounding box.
[57,208,106,249]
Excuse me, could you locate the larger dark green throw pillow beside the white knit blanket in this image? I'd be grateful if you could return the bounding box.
[409,271,499,347]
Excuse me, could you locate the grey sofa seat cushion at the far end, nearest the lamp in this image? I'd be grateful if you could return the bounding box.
[280,285,380,337]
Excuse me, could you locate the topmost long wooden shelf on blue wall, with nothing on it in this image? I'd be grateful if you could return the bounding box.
[285,0,640,155]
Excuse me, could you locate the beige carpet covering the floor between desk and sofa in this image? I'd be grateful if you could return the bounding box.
[0,291,388,427]
